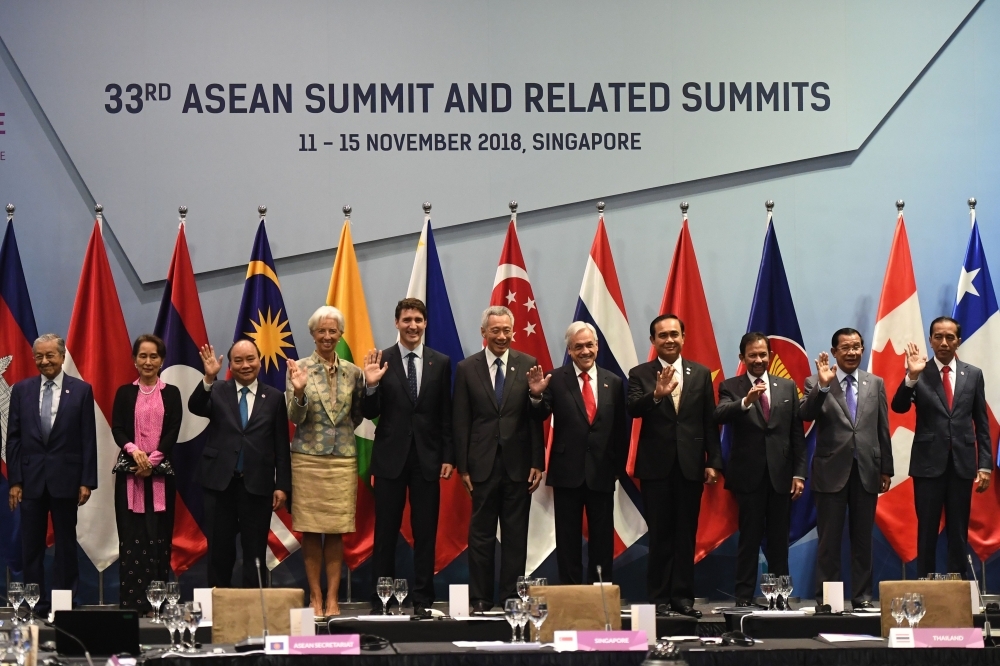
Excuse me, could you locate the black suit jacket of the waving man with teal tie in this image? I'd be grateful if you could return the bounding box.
[188,379,292,496]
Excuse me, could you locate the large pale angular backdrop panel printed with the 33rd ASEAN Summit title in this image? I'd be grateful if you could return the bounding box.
[0,0,975,281]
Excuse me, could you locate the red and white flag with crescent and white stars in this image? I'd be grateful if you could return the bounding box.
[490,208,556,574]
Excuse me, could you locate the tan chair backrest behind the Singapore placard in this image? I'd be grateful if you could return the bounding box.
[530,585,622,643]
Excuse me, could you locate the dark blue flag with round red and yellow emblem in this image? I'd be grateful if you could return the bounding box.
[748,207,816,543]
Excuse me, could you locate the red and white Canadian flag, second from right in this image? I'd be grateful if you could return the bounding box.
[868,201,927,562]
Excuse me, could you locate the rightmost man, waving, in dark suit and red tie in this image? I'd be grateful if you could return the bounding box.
[892,317,993,577]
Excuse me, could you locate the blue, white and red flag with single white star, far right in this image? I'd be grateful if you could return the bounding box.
[951,199,1000,562]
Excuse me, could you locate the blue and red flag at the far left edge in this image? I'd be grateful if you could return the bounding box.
[0,215,38,574]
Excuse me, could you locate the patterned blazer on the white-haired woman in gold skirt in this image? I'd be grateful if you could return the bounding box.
[285,352,365,458]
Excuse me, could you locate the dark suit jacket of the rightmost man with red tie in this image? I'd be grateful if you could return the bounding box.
[892,359,993,479]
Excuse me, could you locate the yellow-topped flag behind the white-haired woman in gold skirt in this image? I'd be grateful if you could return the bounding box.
[326,218,375,570]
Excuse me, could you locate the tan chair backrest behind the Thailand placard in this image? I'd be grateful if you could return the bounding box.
[878,580,979,636]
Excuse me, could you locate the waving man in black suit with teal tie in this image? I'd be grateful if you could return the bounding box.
[188,340,292,587]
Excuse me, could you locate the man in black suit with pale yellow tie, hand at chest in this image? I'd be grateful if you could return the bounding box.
[628,314,722,618]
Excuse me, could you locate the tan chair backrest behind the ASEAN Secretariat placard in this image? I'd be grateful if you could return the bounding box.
[212,587,305,643]
